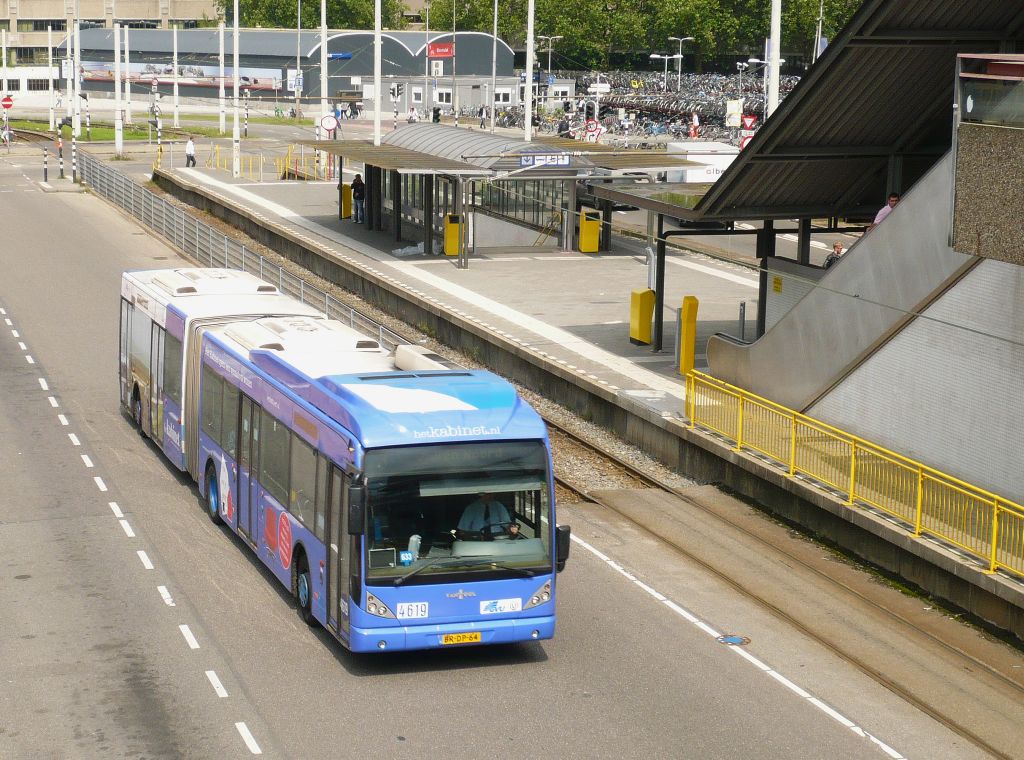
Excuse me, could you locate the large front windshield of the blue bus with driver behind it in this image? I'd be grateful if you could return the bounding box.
[365,440,552,585]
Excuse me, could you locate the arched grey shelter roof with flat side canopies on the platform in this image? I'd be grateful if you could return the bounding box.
[299,123,697,179]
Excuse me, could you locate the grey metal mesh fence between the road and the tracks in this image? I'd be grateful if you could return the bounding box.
[79,154,409,350]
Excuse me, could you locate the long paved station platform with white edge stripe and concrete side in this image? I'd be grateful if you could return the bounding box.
[77,150,1024,638]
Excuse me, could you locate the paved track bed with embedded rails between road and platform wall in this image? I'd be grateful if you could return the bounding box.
[547,419,1024,759]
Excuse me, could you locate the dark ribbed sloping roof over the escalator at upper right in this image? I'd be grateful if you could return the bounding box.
[593,0,1024,220]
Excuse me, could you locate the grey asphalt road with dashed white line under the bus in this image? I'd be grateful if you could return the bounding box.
[0,157,991,759]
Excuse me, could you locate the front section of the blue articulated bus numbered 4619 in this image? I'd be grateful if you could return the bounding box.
[122,276,569,651]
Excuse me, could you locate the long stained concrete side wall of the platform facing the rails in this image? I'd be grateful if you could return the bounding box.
[154,170,1024,640]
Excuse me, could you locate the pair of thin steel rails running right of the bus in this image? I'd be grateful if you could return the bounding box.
[546,417,1024,760]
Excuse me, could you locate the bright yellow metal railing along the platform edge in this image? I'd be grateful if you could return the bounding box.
[686,371,1024,576]
